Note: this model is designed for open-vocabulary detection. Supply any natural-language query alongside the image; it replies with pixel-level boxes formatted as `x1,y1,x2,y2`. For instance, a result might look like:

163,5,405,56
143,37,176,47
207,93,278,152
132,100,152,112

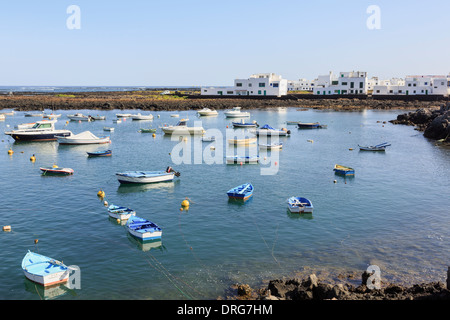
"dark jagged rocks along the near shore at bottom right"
229,267,450,300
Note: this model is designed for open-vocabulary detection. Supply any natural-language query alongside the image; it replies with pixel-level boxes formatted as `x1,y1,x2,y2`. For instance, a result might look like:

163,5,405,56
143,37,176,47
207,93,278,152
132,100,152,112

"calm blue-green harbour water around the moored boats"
0,108,450,300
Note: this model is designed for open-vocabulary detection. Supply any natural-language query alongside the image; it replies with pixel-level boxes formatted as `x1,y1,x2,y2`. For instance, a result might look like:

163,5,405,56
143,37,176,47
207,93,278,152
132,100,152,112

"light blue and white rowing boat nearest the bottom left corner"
22,250,69,287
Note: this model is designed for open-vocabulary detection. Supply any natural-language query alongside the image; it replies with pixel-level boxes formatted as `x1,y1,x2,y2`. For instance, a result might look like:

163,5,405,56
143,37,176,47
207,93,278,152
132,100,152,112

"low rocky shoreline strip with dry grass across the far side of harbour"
0,91,442,111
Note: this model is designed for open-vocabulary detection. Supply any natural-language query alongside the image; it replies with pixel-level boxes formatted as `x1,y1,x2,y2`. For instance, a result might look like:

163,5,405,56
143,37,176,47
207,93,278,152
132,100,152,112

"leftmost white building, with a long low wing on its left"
201,73,288,97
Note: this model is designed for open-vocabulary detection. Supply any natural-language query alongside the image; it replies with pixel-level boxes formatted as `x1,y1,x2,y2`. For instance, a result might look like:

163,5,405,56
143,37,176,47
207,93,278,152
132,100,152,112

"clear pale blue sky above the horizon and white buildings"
0,0,450,86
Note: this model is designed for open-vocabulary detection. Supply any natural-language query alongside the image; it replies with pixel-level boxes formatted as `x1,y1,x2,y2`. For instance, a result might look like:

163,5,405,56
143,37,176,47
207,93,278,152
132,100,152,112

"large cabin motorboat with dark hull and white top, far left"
5,120,72,141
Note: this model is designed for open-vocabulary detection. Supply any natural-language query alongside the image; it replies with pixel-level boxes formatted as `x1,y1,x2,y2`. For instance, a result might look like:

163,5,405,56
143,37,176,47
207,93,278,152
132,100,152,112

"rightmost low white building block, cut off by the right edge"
372,75,450,96
